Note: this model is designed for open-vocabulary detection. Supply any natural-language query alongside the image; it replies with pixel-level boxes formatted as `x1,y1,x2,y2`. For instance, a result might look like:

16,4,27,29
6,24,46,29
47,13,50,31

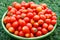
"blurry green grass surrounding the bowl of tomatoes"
0,0,60,40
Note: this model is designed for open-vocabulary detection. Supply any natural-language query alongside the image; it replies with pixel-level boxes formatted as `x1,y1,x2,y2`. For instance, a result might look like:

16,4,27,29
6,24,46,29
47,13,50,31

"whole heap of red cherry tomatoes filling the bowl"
4,1,57,38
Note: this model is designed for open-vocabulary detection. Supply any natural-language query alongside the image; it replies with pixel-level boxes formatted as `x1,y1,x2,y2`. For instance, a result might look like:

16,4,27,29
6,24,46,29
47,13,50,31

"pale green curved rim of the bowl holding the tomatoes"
2,11,57,40
